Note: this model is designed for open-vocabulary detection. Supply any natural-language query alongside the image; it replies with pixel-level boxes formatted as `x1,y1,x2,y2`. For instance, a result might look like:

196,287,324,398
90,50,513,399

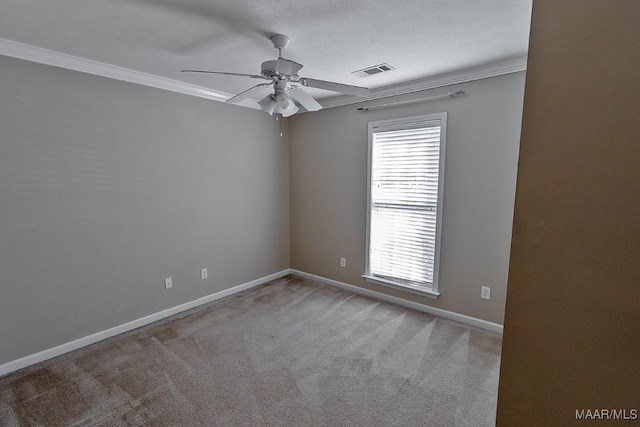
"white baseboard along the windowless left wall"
0,269,291,376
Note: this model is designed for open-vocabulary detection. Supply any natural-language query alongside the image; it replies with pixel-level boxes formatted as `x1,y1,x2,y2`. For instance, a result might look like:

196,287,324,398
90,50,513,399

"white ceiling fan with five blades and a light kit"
182,34,370,117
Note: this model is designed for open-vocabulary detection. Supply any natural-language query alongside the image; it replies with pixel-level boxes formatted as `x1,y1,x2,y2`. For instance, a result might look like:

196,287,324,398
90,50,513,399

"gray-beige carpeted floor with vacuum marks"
0,276,501,427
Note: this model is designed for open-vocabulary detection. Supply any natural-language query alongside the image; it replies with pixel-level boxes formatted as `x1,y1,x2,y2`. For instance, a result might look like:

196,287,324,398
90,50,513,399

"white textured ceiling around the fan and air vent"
0,0,532,103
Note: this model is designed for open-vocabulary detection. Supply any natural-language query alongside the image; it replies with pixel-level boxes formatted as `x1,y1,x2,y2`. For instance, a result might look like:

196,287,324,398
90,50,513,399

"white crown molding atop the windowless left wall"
0,38,260,110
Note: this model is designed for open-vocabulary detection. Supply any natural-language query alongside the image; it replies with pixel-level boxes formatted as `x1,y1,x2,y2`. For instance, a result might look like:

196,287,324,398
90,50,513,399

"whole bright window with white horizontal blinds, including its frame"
364,113,447,298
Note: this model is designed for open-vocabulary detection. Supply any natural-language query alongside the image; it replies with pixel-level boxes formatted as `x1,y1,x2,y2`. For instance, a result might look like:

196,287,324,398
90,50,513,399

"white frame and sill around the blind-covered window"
362,112,447,299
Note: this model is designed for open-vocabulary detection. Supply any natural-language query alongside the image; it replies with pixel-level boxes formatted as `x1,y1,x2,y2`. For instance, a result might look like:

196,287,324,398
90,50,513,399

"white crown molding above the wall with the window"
320,56,527,108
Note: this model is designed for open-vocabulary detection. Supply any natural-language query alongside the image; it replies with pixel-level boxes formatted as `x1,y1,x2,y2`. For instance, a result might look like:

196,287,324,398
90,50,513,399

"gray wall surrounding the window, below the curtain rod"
290,73,524,323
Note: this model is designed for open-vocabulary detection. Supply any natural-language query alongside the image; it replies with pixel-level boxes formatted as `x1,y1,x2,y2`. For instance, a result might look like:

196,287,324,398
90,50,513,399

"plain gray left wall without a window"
0,57,289,364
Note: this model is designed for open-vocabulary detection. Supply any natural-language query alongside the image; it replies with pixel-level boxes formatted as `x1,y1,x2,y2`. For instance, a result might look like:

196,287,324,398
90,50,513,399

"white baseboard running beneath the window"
291,269,503,334
